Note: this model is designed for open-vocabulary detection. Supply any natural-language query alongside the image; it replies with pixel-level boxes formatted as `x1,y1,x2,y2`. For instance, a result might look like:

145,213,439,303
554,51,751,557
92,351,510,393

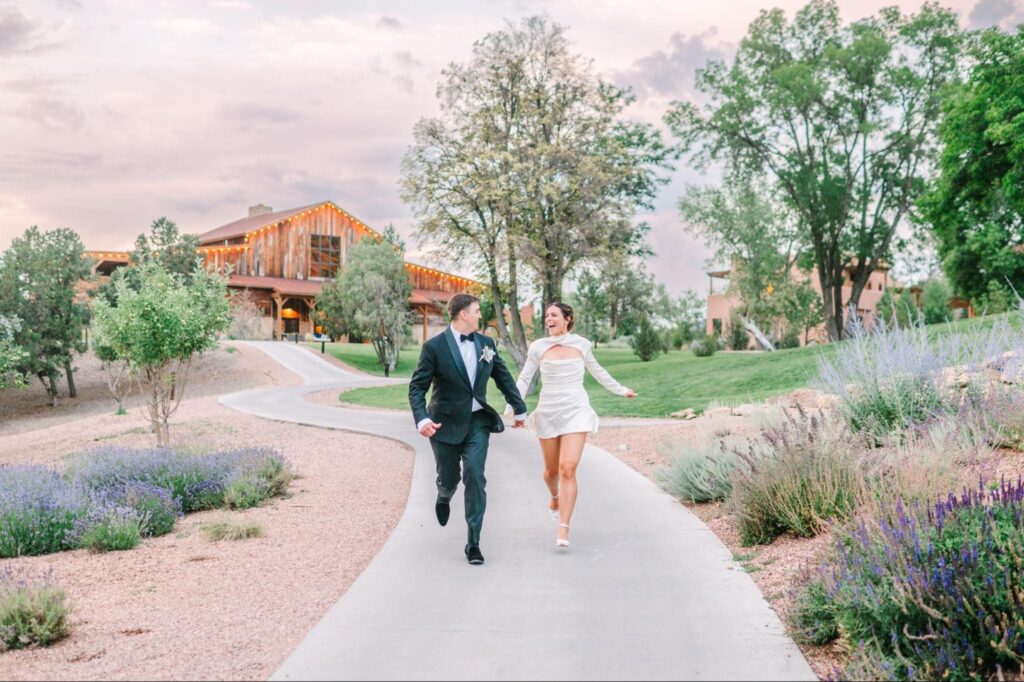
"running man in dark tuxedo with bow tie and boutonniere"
409,294,526,564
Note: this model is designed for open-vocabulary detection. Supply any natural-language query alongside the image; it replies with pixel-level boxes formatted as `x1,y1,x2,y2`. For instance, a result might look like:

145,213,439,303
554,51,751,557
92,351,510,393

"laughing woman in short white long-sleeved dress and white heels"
507,303,636,548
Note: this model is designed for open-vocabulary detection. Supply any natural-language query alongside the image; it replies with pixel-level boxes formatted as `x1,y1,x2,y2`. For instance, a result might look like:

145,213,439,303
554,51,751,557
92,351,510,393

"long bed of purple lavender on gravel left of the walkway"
0,447,294,557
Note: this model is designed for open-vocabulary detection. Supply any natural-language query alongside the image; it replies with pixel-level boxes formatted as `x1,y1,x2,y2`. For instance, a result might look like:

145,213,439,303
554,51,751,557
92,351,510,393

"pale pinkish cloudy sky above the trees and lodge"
0,0,1024,293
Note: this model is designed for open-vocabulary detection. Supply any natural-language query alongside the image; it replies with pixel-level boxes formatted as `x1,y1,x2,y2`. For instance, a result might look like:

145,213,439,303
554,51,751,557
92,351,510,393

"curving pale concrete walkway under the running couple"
220,342,816,680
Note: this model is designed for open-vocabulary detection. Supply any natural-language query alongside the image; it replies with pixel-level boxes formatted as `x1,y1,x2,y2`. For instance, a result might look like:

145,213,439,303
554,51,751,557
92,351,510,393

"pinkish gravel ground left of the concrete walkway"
0,343,413,679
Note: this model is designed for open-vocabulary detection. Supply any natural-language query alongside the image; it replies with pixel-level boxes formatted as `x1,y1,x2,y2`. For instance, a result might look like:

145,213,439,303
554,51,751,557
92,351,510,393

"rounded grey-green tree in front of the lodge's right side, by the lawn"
316,232,413,376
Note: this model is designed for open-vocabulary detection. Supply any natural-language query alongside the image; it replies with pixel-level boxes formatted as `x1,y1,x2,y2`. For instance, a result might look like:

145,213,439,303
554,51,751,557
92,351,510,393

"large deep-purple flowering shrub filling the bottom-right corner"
792,480,1024,679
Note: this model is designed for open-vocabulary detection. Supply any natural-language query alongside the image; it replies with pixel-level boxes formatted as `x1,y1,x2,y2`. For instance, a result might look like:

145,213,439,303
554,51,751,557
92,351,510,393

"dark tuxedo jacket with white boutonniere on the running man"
409,327,526,444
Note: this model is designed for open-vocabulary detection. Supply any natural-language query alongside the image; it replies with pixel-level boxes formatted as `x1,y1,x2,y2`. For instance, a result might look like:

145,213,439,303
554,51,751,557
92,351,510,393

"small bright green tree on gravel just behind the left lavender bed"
92,259,230,446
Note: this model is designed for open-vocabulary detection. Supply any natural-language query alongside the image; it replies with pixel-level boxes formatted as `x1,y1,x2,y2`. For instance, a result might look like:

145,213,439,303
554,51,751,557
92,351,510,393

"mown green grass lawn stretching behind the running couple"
315,313,1024,417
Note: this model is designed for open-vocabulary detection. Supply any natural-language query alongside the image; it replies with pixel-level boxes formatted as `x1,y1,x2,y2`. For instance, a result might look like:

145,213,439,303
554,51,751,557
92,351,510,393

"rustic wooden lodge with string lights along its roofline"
86,202,482,343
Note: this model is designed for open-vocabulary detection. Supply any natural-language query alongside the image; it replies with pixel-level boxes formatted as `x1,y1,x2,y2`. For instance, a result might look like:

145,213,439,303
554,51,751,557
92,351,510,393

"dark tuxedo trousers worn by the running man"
430,410,490,545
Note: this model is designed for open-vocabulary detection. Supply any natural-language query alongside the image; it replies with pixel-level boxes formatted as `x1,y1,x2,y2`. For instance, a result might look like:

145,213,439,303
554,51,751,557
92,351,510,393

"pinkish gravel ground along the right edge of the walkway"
589,415,842,679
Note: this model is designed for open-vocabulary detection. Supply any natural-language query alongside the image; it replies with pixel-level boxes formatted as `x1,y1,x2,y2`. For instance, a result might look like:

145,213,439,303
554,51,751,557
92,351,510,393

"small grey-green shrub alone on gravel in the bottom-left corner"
0,566,71,652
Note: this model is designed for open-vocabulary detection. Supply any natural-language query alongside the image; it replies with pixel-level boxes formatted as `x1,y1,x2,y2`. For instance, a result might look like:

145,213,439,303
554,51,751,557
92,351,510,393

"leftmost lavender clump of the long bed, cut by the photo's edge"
0,465,91,558
